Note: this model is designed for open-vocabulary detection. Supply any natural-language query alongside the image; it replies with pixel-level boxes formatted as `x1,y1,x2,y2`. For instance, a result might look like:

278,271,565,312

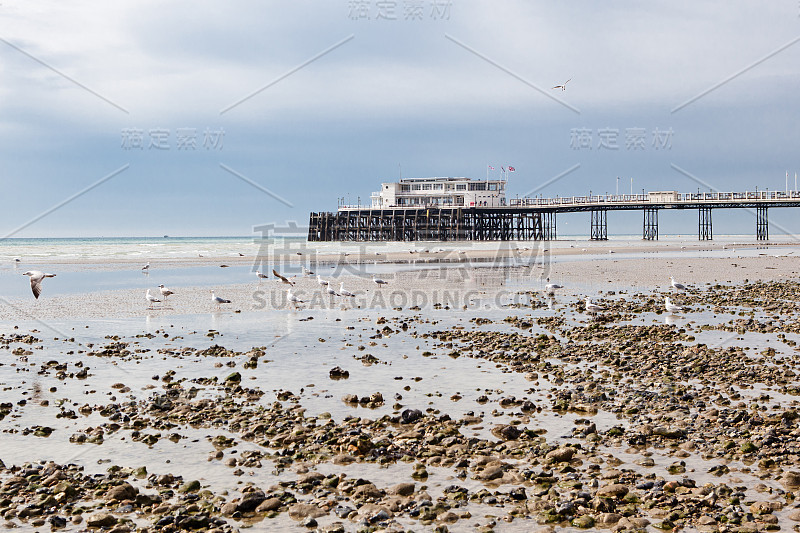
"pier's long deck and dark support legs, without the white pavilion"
308,191,800,242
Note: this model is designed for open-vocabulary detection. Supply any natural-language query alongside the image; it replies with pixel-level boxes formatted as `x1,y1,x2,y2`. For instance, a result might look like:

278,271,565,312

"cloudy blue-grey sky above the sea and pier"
0,0,800,237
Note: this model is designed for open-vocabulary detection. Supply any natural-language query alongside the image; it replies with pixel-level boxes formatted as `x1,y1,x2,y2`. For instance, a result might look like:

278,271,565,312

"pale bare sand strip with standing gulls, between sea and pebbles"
0,253,800,322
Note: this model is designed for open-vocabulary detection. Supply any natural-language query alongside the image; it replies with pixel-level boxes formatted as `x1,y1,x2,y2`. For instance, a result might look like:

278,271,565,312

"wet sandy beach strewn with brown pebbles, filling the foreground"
0,246,800,533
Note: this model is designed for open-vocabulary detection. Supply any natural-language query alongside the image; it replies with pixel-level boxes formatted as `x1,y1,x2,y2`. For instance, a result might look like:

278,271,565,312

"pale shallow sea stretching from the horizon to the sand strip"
0,233,793,298
